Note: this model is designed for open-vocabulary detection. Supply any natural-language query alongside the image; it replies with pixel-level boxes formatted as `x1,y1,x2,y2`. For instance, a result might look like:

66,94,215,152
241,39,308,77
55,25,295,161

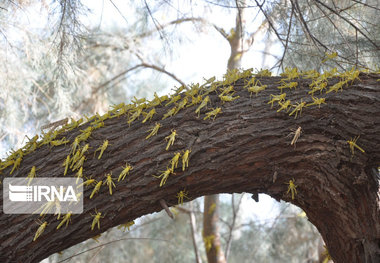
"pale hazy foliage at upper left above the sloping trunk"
0,0,168,156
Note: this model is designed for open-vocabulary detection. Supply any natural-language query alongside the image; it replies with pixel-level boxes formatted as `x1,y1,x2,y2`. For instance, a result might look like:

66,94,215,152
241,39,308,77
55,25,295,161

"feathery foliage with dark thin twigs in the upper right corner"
269,0,380,71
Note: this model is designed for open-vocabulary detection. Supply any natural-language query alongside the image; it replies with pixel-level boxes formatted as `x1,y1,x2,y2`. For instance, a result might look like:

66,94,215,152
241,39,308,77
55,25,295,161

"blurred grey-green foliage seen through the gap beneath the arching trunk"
50,194,319,263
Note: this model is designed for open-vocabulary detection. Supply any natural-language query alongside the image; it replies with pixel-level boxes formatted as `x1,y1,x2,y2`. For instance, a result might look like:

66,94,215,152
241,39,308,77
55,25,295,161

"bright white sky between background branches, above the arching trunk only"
83,0,282,94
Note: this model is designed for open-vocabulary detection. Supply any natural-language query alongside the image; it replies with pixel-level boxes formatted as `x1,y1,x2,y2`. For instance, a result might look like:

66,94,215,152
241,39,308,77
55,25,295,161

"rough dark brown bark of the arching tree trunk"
0,74,380,263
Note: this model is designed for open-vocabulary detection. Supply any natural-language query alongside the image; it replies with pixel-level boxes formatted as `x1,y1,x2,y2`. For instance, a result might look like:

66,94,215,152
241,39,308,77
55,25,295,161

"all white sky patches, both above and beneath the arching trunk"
0,0,288,225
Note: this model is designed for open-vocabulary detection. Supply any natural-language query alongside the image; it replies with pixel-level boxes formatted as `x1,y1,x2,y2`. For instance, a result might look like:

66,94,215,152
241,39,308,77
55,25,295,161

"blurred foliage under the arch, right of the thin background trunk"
220,198,319,263
